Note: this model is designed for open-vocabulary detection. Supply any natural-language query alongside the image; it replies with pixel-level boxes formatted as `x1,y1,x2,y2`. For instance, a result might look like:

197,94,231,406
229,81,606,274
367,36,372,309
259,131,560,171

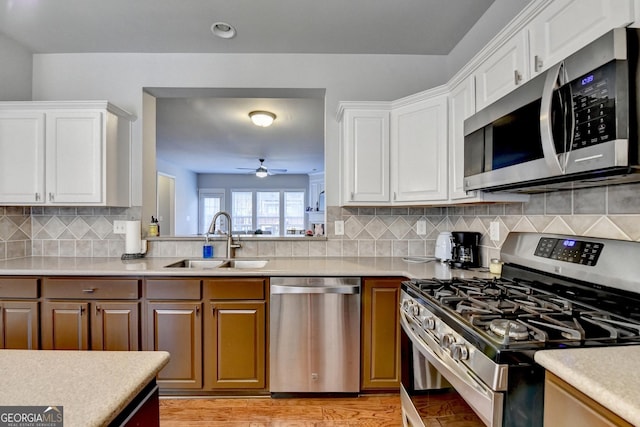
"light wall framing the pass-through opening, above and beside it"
33,53,446,205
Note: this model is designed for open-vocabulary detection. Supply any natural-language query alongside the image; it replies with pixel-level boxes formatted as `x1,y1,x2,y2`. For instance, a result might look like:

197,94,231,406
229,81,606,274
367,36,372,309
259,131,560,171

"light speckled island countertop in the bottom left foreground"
0,350,169,427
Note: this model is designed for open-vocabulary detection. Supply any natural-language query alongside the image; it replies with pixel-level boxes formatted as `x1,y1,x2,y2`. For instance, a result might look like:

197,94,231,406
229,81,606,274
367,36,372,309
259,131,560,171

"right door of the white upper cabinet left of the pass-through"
46,111,104,203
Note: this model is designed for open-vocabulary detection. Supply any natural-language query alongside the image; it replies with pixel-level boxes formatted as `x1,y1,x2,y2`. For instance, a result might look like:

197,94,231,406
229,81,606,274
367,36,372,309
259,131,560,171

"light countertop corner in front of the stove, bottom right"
534,345,640,425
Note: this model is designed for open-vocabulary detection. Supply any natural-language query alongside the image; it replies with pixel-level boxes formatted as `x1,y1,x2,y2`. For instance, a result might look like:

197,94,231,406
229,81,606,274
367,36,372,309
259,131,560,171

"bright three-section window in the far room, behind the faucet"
231,190,306,236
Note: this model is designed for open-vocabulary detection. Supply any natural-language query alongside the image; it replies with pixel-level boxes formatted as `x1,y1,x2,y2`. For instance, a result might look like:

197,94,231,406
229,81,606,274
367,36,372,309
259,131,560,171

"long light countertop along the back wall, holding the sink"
0,257,490,279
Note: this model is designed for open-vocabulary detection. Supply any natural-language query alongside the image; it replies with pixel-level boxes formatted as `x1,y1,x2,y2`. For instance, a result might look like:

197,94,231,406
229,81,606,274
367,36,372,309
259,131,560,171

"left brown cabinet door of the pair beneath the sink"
146,301,202,389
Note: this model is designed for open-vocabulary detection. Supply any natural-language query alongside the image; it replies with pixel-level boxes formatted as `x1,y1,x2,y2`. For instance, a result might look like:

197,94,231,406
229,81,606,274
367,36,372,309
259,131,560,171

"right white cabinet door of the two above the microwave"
529,0,634,75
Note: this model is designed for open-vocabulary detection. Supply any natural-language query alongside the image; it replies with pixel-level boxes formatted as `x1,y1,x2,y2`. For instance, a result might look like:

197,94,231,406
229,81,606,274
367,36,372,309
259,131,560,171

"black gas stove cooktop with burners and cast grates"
404,278,640,349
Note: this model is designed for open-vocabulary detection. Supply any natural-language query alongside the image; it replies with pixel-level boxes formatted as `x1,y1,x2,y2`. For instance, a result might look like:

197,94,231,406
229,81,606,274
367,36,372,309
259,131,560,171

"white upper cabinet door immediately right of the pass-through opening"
342,109,390,205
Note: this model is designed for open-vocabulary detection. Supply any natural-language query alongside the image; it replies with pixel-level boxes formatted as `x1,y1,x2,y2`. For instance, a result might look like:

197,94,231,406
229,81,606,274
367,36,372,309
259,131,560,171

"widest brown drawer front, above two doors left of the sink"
42,277,140,300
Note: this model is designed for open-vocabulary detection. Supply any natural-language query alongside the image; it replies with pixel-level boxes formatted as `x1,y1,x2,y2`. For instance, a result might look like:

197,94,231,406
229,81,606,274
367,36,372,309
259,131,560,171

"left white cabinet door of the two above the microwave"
474,31,529,111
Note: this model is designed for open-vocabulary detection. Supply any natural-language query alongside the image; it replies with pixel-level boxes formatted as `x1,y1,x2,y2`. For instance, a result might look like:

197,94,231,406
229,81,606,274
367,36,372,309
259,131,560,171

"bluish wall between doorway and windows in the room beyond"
156,159,198,236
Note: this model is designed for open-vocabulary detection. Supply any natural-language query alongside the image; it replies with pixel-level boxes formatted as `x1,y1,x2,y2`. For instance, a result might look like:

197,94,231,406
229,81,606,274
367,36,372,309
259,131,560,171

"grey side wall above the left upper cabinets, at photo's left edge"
0,34,32,101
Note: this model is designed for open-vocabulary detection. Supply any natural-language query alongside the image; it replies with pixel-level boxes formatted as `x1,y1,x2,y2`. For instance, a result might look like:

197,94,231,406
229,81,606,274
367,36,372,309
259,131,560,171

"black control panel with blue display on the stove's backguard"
534,237,604,266
